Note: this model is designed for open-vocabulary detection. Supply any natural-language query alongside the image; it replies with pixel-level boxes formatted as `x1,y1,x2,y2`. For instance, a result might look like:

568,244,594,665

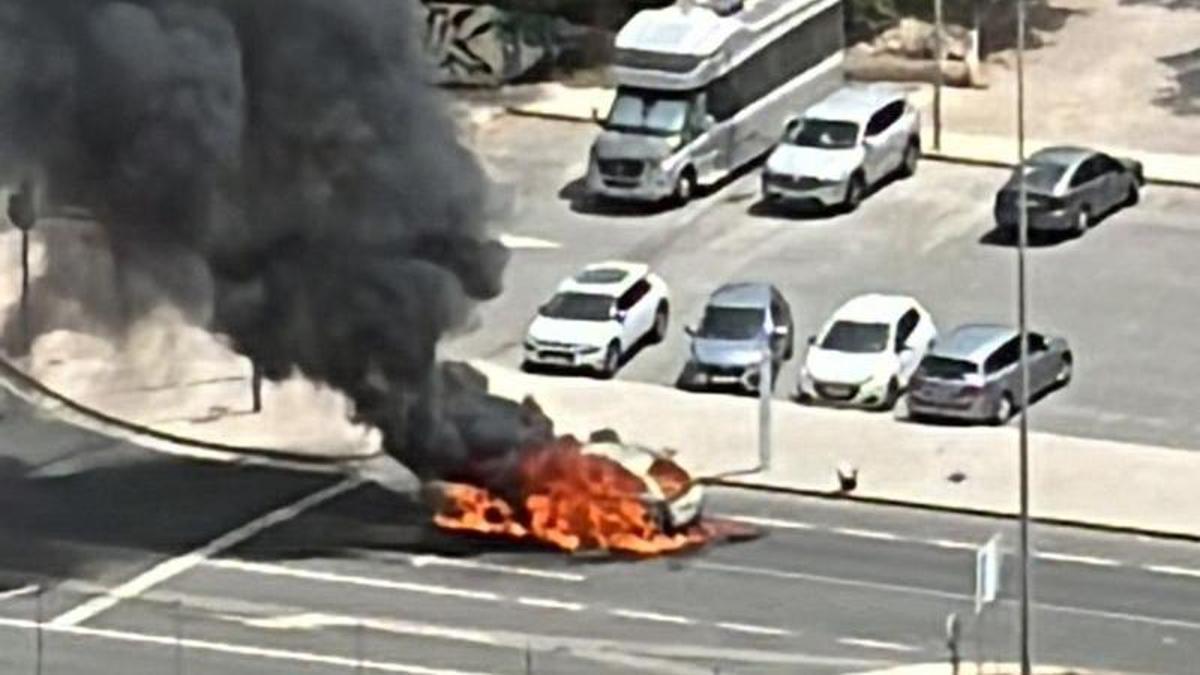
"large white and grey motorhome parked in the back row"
587,0,845,202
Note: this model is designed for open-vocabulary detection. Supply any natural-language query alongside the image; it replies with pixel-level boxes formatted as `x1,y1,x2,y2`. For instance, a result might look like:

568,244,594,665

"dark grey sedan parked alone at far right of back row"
995,145,1146,234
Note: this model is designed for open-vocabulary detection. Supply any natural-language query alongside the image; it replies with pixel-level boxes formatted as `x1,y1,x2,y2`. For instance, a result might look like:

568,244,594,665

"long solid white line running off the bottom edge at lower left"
0,619,488,675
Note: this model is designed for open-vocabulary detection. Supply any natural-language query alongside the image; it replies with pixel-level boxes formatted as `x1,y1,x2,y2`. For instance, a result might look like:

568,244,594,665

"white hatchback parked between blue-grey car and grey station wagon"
798,293,937,410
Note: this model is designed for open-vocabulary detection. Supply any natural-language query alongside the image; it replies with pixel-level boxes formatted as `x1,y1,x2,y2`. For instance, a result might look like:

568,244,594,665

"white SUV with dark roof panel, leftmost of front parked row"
524,262,671,377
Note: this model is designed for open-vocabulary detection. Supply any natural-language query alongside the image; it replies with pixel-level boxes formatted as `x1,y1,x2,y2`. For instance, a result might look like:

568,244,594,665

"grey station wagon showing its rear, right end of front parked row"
908,324,1074,424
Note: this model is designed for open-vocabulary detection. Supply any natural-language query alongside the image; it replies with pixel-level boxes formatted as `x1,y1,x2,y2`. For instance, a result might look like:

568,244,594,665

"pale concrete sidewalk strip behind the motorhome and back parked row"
504,83,1200,187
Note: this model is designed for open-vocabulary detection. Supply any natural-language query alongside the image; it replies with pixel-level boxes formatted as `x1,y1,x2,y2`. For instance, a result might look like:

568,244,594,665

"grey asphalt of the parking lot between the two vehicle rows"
444,117,1200,449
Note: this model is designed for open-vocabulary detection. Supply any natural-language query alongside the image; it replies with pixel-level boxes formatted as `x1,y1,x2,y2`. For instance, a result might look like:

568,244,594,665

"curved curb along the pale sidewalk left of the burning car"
0,357,383,468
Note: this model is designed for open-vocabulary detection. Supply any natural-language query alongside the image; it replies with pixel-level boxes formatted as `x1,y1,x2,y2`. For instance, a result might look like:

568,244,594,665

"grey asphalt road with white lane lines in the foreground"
0,393,1200,675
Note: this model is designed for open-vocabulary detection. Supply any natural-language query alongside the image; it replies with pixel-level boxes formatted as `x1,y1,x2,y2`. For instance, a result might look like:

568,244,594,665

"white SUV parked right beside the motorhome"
762,85,920,209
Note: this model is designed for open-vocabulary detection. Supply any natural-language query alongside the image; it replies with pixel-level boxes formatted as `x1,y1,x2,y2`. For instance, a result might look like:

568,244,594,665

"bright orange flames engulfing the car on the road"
434,440,707,555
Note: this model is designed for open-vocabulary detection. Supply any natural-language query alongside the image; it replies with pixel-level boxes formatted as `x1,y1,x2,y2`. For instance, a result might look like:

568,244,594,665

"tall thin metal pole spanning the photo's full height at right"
1016,0,1033,675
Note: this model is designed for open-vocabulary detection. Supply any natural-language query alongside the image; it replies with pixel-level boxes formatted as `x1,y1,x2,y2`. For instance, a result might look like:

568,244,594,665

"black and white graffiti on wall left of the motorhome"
425,2,553,85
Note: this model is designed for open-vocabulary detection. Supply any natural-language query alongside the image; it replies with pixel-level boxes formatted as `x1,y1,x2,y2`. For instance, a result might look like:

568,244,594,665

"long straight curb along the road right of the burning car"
707,479,1200,543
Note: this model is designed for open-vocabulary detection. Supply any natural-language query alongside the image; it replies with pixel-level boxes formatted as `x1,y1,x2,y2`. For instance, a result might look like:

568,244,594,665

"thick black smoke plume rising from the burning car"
0,0,550,478
